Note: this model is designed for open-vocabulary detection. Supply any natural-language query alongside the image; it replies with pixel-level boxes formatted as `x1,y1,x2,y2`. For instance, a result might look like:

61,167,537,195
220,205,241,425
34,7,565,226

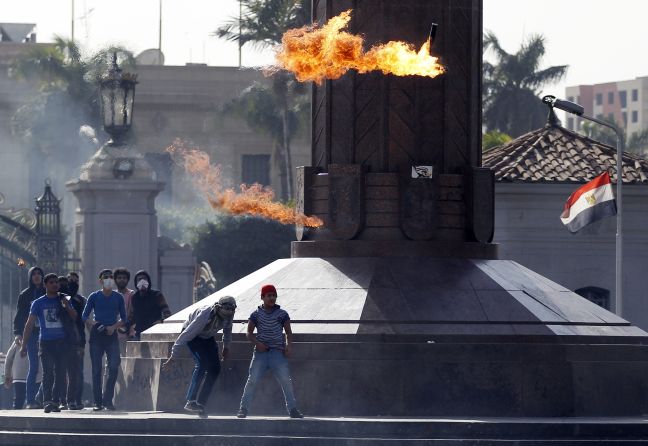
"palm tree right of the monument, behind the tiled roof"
483,32,567,137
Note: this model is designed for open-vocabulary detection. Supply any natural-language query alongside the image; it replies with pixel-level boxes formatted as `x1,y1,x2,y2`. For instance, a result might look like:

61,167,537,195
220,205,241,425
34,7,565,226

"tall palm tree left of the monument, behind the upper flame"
215,0,311,200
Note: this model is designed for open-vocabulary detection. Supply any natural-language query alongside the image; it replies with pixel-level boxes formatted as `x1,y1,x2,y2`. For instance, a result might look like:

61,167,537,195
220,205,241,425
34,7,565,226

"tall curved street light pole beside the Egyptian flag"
542,95,625,317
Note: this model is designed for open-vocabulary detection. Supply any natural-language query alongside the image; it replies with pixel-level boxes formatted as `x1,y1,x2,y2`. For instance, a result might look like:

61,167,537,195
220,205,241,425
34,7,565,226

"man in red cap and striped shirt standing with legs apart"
236,285,304,418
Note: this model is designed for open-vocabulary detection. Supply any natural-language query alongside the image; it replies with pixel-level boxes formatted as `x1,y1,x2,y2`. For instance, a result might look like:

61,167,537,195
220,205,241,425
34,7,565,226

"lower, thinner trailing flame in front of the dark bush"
166,140,324,228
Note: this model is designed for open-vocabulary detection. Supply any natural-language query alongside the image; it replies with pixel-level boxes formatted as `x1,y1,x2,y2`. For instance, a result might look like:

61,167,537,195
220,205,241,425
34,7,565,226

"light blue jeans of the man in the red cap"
241,349,297,411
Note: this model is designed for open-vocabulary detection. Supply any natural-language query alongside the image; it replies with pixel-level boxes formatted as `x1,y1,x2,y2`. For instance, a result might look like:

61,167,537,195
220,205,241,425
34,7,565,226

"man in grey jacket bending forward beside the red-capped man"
162,296,236,414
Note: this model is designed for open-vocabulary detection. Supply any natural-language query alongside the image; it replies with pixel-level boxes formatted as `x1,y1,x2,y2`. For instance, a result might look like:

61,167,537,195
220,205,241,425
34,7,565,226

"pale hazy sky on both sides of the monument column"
0,0,648,96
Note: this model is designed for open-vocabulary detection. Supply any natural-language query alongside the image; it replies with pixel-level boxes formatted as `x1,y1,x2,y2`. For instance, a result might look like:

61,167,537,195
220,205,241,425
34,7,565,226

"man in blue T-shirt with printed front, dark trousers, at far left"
20,274,77,413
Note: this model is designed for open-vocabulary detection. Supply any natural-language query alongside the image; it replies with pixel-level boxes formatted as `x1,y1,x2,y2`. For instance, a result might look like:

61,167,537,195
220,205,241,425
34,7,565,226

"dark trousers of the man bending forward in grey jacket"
187,337,220,405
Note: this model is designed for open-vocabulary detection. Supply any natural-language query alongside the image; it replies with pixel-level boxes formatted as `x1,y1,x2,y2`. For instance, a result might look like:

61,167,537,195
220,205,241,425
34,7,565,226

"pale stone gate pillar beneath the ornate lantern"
66,144,164,295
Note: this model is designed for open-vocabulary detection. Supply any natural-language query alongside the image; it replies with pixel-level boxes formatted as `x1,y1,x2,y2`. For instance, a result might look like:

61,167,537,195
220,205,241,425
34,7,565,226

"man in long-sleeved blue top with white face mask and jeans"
82,269,126,410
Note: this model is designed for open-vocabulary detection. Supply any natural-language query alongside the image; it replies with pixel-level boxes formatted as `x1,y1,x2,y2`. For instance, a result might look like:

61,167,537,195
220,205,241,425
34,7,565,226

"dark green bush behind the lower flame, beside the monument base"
191,216,295,288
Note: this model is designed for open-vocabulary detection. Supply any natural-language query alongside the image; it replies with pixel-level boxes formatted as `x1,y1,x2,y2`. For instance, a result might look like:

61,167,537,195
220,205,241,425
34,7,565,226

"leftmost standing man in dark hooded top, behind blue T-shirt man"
14,266,45,409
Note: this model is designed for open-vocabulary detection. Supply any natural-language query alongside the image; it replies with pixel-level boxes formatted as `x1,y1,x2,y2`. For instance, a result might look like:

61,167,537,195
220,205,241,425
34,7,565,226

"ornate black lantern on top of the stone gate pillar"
99,53,137,145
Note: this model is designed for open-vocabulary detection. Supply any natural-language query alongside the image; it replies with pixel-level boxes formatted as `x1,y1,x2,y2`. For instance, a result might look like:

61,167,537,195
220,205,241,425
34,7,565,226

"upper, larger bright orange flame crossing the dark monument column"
276,10,445,84
